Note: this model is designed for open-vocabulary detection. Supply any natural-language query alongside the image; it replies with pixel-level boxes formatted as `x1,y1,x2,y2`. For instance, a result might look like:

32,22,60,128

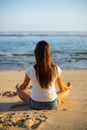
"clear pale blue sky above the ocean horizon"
0,0,87,31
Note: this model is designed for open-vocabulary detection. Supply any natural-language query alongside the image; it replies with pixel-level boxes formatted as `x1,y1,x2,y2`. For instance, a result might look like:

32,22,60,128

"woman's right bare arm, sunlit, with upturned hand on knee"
57,76,72,91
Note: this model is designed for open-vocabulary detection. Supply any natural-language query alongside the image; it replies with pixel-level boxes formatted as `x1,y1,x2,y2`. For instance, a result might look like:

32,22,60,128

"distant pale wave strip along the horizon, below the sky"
0,32,87,37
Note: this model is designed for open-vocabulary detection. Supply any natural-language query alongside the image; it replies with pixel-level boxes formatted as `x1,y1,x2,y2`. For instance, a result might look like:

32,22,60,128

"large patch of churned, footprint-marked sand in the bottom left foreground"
0,112,47,130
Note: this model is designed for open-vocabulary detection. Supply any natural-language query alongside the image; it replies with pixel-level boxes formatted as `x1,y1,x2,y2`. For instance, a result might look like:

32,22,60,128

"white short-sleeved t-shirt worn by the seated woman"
26,66,61,102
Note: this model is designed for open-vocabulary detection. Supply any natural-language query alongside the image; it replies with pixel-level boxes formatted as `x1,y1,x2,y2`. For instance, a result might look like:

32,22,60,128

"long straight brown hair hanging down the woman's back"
34,41,57,88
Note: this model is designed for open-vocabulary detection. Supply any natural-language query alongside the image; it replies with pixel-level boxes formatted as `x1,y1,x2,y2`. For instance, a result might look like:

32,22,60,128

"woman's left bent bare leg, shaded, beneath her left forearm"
16,90,30,104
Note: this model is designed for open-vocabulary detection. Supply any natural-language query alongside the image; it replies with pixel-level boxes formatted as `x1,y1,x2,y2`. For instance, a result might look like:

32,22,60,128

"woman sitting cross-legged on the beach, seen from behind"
16,41,71,110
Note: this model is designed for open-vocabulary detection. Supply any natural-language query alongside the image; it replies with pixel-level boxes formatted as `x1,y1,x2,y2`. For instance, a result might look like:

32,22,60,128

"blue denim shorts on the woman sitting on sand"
29,97,58,110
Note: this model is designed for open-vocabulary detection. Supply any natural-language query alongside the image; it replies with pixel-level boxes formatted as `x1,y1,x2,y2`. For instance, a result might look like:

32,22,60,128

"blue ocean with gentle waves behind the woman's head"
0,32,87,70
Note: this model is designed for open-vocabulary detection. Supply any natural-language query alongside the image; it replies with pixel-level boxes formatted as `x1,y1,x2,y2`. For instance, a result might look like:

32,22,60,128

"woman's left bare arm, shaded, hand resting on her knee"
16,74,30,90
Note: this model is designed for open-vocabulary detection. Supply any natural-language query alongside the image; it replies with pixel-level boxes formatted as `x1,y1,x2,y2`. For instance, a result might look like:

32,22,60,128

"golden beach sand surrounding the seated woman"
0,70,87,130
